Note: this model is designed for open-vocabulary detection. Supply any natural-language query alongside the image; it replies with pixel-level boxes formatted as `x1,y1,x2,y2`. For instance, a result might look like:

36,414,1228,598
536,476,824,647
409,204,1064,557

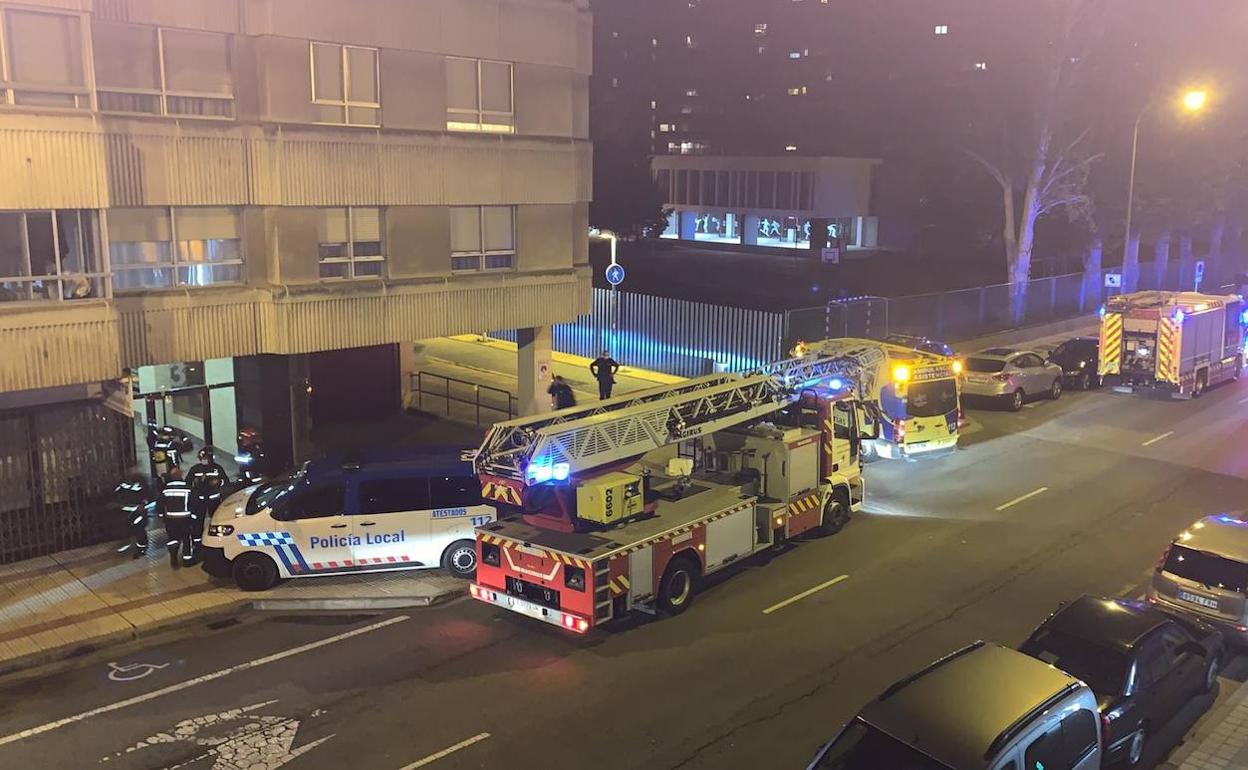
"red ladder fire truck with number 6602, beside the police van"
469,354,875,634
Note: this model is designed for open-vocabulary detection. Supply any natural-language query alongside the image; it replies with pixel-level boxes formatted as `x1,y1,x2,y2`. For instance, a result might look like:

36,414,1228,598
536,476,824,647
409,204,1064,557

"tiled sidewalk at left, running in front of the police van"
0,532,466,674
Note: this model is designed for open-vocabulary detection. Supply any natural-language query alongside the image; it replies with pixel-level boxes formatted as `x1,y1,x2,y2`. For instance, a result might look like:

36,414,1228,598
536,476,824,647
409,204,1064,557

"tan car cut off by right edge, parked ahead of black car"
1147,513,1248,646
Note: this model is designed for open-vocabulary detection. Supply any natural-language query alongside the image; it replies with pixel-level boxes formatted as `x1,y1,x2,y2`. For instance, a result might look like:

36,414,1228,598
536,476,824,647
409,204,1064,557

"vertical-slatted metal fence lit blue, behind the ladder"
490,288,785,377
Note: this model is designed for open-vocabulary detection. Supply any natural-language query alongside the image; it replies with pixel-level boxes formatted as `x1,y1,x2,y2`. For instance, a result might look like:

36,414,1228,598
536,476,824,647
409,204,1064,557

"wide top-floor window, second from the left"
92,24,235,119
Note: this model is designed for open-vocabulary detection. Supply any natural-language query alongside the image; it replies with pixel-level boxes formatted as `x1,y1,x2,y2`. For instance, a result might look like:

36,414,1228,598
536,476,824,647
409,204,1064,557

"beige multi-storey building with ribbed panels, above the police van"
0,0,592,560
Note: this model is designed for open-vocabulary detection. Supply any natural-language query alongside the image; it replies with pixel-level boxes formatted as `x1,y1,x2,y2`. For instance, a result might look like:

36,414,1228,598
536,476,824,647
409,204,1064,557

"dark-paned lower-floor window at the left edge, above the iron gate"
0,211,105,302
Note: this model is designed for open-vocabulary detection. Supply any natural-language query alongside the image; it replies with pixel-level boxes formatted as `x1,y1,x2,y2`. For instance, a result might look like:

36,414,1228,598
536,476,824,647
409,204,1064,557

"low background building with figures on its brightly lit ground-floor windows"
651,155,880,250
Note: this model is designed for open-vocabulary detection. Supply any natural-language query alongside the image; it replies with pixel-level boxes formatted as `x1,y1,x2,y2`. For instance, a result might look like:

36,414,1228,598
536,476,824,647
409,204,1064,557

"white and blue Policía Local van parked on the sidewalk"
203,449,497,590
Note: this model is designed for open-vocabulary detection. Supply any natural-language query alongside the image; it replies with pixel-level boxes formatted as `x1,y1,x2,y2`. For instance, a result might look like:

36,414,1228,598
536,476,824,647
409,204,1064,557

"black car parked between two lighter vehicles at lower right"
1020,597,1222,766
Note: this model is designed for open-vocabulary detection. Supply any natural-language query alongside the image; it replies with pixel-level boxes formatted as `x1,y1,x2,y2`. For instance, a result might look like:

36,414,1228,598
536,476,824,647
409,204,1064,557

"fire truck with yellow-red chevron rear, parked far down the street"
1099,291,1248,397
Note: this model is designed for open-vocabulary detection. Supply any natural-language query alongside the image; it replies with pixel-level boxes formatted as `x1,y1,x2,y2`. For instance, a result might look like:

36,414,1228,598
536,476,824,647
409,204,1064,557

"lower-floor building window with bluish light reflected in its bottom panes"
109,206,242,291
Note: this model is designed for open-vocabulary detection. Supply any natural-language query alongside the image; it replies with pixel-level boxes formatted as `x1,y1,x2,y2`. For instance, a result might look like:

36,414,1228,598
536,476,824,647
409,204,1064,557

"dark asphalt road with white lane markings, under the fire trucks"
0,381,1248,770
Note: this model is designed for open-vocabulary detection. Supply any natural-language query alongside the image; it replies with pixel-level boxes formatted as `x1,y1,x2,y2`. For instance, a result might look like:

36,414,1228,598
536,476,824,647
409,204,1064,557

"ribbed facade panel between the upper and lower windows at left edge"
0,125,106,210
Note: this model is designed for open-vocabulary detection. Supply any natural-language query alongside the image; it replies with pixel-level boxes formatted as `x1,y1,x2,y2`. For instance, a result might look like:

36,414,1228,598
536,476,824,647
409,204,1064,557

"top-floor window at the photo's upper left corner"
0,9,91,110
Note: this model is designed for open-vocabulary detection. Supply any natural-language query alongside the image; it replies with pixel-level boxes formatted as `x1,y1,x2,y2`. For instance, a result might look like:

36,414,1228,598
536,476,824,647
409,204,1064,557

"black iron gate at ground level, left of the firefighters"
0,402,135,564
